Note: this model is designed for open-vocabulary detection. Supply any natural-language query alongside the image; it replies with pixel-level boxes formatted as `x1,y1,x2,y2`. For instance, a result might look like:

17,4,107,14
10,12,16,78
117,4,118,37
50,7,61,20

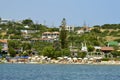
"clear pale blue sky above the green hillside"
0,0,120,27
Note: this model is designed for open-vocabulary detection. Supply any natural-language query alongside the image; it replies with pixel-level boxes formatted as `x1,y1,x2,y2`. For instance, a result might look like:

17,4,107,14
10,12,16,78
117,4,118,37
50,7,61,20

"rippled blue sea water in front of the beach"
0,64,120,80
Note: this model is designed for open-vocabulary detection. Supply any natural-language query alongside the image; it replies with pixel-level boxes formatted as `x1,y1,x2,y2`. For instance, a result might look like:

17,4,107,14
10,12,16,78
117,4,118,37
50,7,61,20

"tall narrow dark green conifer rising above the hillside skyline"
60,18,68,49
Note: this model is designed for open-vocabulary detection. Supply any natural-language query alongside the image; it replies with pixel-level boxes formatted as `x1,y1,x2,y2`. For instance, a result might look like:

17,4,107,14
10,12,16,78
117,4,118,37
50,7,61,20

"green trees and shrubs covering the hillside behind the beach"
0,18,120,58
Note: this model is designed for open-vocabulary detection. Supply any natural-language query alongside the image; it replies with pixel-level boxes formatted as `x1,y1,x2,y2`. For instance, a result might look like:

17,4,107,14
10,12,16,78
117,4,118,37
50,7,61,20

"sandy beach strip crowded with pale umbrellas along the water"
0,56,120,65
